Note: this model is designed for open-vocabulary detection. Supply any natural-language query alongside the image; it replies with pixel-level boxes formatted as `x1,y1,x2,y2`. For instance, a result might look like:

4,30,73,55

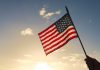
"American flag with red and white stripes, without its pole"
38,13,77,55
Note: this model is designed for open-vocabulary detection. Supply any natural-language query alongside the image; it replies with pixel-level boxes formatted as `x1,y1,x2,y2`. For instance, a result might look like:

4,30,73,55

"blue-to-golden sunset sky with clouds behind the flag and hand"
0,0,100,70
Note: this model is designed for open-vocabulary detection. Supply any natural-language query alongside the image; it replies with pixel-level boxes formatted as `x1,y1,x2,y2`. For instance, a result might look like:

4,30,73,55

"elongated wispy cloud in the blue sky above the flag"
39,8,61,19
